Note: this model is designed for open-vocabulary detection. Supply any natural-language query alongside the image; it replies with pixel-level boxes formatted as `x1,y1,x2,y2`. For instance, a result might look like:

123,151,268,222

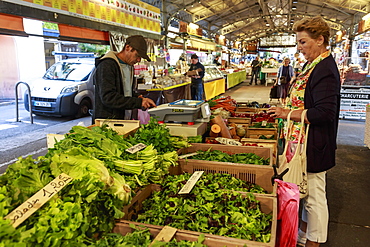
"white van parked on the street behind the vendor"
24,57,95,117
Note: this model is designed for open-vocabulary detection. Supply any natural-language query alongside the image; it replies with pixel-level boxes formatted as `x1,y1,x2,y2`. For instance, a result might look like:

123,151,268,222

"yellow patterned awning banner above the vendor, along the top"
4,0,161,33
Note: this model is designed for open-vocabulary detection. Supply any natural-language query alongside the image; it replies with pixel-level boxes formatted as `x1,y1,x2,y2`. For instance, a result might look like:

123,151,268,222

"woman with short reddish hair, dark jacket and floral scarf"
268,16,341,247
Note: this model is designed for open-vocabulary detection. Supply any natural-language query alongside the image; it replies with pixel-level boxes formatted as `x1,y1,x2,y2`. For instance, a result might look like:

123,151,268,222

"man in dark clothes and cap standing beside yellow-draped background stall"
188,54,205,100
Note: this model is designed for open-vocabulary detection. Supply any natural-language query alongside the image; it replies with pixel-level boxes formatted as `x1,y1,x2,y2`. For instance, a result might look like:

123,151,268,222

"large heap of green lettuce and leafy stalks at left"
0,123,181,247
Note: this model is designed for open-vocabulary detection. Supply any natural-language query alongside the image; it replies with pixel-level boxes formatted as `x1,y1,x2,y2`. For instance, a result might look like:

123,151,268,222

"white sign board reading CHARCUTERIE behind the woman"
339,92,370,119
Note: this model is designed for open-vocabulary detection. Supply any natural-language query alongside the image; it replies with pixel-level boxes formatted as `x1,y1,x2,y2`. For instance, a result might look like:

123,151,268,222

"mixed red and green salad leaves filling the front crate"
136,174,272,243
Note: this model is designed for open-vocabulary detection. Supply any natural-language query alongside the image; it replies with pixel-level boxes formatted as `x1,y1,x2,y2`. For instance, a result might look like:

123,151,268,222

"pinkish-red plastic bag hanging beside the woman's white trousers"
275,179,299,247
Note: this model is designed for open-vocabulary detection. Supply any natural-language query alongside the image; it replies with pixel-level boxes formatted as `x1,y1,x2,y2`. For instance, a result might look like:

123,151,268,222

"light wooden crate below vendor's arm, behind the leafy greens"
95,119,140,137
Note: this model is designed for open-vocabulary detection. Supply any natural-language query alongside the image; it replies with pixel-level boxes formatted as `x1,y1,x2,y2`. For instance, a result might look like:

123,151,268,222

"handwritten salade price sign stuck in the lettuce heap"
5,173,73,228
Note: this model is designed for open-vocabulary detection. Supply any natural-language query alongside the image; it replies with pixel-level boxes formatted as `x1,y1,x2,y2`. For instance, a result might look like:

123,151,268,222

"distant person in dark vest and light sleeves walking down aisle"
275,57,295,106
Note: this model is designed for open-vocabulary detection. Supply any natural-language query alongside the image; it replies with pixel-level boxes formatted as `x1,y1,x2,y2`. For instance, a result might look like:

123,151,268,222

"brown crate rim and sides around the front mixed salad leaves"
117,184,277,247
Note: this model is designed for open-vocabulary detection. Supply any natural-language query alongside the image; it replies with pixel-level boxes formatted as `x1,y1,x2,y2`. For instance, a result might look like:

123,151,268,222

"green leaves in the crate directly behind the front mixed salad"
188,149,270,165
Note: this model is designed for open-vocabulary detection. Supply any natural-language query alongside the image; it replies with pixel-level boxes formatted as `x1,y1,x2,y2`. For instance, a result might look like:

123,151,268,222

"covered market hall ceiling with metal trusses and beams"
143,0,370,41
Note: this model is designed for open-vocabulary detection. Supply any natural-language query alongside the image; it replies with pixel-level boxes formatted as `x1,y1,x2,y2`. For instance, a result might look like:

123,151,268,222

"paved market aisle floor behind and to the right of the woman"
224,80,370,247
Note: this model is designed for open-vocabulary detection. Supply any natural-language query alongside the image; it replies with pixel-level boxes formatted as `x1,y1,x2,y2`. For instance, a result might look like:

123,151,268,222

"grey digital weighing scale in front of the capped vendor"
148,99,211,125
